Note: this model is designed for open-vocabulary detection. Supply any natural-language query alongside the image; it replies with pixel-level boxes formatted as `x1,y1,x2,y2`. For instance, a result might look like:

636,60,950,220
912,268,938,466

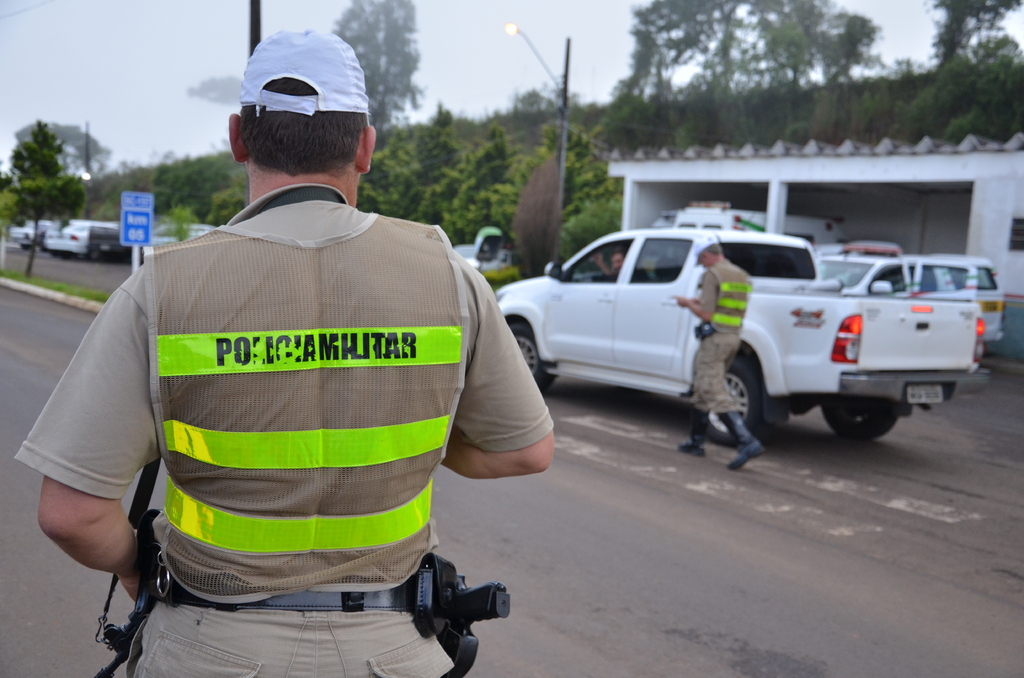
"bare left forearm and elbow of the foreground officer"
39,477,138,598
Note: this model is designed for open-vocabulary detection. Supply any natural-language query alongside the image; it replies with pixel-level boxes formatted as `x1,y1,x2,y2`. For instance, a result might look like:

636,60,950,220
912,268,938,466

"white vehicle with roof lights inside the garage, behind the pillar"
651,201,844,245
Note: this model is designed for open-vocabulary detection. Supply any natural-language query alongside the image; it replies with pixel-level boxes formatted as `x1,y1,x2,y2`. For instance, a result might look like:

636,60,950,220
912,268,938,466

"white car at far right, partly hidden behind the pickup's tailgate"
904,254,1006,348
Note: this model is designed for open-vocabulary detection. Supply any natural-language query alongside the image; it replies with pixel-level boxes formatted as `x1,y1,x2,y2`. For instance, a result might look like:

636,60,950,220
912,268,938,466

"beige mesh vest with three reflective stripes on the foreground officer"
146,208,466,601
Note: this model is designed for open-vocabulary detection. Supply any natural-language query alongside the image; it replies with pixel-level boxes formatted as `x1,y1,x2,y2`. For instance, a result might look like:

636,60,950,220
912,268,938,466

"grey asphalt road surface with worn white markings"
0,289,1024,678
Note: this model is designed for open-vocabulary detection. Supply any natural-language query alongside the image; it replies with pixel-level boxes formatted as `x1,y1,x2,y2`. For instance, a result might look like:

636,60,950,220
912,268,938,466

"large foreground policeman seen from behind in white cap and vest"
17,32,553,678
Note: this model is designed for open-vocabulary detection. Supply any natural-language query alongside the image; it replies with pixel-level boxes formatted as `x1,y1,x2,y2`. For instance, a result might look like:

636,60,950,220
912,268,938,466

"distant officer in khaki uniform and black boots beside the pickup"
676,243,764,470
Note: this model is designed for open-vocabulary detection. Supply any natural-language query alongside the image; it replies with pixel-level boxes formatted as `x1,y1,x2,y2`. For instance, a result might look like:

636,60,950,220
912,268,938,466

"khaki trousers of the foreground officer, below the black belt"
126,603,452,678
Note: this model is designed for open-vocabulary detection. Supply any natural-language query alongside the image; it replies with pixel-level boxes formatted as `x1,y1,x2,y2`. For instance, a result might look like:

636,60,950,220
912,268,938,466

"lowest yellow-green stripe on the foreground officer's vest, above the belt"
164,478,433,553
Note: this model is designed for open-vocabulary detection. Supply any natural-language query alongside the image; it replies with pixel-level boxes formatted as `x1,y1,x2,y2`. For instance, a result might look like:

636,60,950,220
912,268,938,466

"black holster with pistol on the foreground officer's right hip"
411,553,511,678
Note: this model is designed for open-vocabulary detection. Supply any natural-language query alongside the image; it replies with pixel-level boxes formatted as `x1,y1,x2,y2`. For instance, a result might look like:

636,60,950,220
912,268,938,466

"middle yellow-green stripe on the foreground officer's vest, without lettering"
164,416,449,468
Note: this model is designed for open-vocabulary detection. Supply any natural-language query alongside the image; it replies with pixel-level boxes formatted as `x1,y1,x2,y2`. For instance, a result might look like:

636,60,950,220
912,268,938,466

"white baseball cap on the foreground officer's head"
239,31,370,116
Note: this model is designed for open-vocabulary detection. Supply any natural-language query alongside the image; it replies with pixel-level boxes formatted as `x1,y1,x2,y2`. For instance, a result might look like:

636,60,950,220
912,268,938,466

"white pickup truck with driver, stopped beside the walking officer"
497,228,988,442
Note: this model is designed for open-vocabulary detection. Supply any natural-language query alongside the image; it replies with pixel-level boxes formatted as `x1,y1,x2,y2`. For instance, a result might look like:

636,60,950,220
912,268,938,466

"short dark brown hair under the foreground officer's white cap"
241,78,368,176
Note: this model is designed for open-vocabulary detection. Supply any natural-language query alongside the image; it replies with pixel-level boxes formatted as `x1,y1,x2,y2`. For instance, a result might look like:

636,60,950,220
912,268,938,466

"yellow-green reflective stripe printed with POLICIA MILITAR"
157,326,462,377
